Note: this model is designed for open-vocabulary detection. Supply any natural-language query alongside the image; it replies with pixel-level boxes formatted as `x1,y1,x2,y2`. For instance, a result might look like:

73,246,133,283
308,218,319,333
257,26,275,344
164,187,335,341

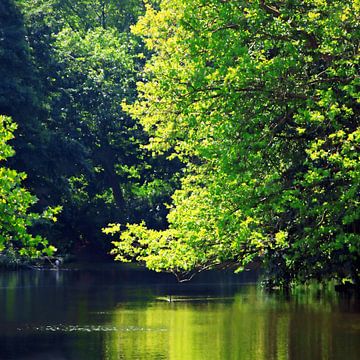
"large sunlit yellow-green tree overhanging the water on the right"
105,0,360,286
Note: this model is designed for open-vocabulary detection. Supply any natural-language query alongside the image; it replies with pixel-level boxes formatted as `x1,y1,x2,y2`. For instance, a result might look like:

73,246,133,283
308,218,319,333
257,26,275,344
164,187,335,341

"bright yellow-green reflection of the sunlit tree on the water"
103,287,359,360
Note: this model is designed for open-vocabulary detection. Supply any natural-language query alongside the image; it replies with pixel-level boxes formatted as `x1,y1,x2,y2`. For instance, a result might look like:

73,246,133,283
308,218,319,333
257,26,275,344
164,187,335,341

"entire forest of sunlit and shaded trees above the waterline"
0,0,360,287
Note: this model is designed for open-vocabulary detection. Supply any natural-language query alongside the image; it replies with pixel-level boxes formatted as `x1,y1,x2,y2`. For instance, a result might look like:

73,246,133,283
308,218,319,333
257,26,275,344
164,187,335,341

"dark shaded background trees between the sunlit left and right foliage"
0,0,179,251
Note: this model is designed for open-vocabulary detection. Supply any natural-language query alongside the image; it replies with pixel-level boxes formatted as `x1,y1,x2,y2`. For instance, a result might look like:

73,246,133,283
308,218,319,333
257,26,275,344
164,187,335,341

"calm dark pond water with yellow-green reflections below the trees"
0,264,360,360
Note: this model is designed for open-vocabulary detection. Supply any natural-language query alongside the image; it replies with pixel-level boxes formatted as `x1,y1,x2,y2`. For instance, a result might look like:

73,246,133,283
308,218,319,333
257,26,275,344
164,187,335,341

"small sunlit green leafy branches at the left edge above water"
0,116,60,257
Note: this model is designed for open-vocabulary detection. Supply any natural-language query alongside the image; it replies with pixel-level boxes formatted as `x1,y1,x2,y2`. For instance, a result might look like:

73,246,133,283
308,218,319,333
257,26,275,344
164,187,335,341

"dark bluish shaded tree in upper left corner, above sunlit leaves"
0,0,49,183
